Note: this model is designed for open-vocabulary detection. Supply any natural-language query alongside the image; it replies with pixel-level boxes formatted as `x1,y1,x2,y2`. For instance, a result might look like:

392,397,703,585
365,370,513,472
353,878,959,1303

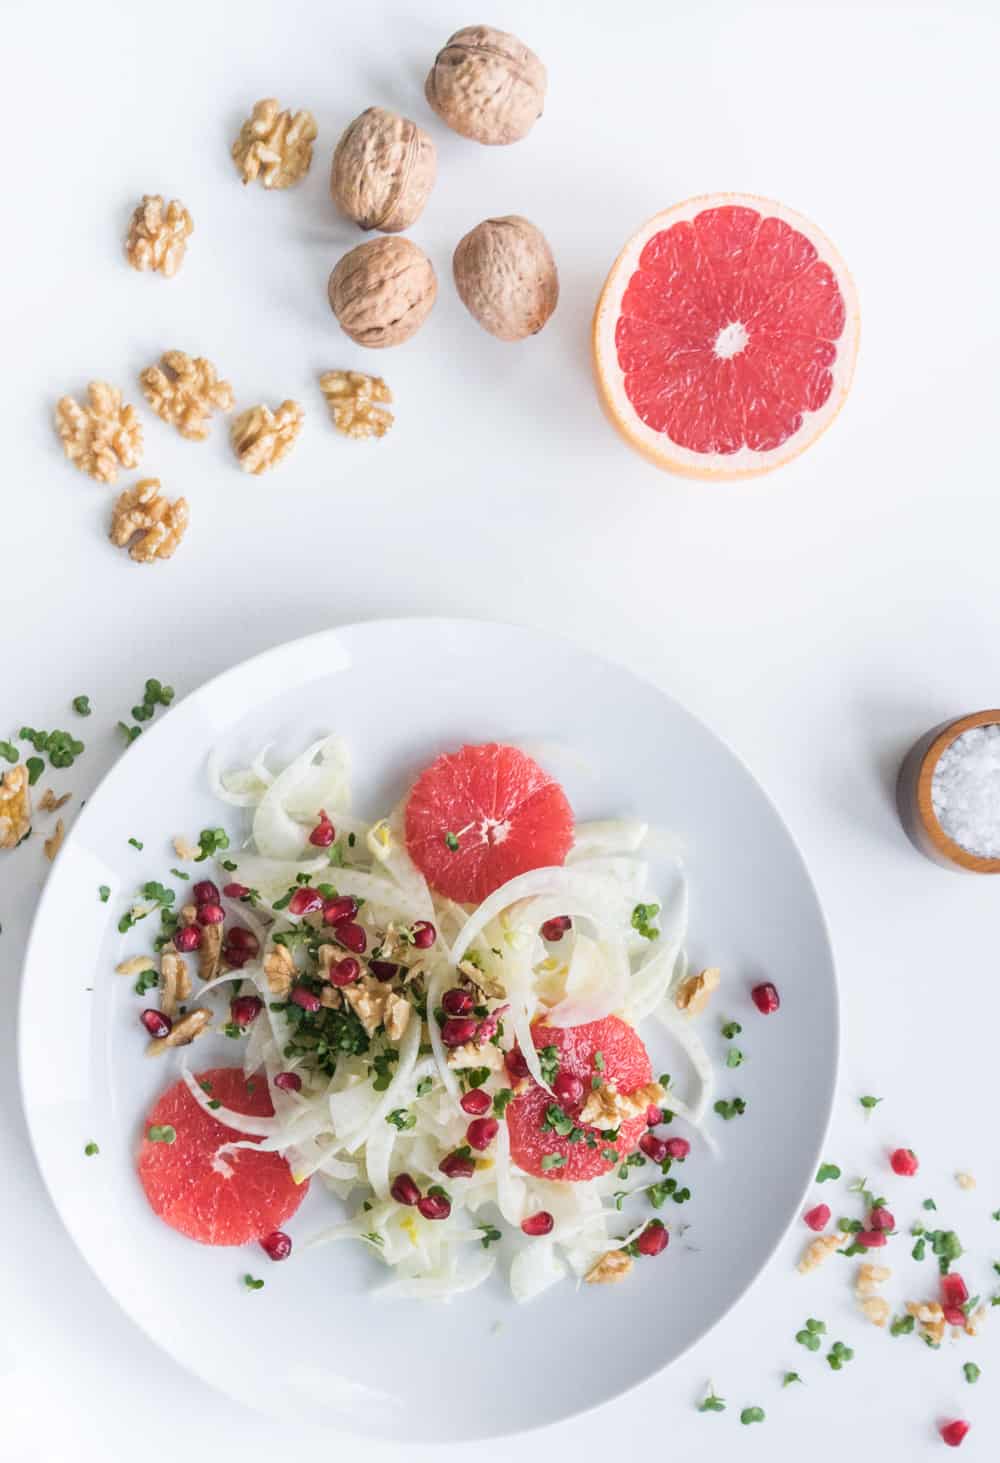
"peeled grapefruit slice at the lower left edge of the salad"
139,1067,308,1245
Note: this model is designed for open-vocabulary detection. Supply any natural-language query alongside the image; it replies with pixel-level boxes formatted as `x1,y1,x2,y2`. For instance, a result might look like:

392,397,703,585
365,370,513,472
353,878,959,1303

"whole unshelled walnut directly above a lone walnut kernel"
329,236,437,350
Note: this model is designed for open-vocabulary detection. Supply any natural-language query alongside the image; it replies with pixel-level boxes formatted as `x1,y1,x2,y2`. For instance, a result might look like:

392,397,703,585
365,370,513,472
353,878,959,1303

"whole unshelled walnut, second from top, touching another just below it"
330,107,437,234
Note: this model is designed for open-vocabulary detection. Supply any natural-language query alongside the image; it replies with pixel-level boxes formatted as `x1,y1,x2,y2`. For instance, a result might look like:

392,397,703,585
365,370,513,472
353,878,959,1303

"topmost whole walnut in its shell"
424,25,547,145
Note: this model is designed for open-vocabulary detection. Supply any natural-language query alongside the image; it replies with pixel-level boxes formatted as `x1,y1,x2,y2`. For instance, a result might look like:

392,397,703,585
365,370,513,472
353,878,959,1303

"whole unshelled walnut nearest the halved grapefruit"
452,214,558,341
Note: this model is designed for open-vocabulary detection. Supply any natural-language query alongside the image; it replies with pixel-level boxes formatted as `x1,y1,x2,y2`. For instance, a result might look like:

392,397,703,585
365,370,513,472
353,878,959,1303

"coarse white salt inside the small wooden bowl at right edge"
931,723,1000,859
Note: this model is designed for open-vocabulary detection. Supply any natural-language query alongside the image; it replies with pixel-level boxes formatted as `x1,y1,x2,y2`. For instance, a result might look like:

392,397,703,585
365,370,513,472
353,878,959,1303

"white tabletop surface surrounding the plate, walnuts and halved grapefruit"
0,0,1000,1463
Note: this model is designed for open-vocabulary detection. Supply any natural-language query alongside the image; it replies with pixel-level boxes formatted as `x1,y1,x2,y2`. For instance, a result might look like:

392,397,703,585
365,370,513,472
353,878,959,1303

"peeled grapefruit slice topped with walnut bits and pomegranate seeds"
506,1015,652,1182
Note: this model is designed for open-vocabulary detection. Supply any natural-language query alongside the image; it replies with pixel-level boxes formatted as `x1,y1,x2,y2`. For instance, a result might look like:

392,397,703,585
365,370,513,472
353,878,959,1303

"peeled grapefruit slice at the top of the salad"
406,742,573,904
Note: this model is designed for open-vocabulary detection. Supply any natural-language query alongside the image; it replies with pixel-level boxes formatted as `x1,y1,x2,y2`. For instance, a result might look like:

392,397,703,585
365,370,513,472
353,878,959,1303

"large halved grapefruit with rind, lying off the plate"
592,193,858,480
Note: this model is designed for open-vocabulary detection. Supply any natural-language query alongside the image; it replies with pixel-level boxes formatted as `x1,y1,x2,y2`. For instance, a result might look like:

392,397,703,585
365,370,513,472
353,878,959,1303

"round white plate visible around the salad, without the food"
20,620,838,1443
